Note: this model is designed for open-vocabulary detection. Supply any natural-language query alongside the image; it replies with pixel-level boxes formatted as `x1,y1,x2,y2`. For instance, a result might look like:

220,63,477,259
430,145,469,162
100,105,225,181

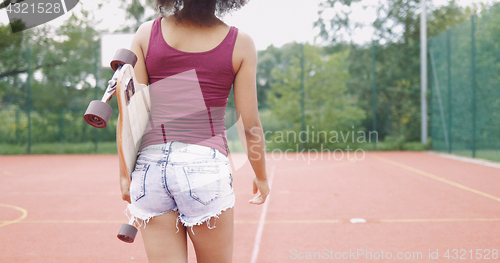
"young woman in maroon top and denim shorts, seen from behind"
121,0,269,263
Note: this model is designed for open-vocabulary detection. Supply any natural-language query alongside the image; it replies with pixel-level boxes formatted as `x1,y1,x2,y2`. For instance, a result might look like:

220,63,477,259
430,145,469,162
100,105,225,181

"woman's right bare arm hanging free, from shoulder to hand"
233,30,269,204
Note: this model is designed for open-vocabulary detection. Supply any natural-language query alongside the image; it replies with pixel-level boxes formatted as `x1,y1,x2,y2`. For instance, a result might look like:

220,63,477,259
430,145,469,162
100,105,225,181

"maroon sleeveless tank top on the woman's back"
140,17,238,155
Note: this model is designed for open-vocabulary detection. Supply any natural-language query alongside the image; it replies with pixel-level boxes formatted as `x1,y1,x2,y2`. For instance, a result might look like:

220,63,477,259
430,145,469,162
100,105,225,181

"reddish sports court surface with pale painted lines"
0,152,500,263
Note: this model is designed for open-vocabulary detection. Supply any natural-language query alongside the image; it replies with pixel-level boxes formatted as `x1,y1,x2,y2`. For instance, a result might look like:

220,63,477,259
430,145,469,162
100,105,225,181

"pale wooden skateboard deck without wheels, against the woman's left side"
116,64,151,183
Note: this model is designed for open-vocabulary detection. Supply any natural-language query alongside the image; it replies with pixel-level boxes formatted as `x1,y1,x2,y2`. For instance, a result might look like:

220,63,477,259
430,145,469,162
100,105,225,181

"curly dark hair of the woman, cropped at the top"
156,0,249,26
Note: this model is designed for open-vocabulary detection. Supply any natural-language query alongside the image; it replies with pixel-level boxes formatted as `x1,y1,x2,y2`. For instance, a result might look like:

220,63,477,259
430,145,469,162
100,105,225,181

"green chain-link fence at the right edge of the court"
429,5,500,161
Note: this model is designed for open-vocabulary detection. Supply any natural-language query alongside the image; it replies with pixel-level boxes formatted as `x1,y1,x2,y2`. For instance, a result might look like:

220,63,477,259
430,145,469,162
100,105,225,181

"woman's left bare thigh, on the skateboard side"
141,211,187,263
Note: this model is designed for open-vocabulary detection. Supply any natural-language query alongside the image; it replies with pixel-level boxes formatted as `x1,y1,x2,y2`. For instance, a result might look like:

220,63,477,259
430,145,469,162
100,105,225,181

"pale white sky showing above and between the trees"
0,0,494,50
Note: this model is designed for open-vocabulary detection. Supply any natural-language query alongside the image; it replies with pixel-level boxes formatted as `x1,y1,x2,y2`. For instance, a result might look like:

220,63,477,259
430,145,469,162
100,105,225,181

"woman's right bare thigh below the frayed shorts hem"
187,208,234,263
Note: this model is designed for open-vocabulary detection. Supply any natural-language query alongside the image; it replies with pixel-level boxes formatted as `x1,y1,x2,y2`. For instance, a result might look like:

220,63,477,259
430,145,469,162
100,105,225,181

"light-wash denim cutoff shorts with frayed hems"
127,141,235,228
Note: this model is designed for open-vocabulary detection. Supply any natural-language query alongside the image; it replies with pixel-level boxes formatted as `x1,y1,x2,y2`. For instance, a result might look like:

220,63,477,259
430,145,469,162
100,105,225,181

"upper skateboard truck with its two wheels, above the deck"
83,48,137,129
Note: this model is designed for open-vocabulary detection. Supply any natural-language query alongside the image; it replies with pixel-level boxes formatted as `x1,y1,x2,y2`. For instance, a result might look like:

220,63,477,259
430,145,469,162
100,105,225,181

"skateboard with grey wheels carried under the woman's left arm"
84,49,151,243
